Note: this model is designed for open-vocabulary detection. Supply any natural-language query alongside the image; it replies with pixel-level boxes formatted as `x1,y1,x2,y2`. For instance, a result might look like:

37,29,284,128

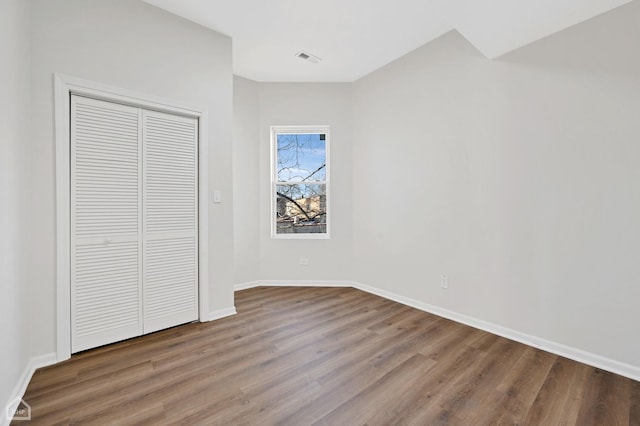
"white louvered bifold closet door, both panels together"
71,95,198,352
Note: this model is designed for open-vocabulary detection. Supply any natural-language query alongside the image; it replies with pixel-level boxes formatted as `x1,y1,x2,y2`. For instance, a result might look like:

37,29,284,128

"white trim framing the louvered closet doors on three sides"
54,74,209,362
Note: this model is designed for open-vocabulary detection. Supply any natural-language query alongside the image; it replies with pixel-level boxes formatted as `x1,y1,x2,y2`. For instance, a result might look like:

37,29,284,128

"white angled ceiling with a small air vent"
144,0,630,82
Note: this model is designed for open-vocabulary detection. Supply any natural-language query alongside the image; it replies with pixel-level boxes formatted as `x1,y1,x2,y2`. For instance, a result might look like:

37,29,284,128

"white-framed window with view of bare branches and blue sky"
271,126,329,238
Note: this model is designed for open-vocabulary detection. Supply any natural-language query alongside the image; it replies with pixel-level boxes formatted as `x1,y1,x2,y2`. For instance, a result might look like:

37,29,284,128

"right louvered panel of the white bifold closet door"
143,111,198,333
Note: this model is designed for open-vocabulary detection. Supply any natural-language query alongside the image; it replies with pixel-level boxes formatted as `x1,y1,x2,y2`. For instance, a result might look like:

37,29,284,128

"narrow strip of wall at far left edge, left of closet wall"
0,0,30,412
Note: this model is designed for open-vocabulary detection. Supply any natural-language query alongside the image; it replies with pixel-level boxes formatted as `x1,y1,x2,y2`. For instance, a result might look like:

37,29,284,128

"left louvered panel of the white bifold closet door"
71,96,142,352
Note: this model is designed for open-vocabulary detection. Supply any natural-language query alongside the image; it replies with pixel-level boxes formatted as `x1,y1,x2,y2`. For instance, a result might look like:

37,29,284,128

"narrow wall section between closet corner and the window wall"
233,76,260,283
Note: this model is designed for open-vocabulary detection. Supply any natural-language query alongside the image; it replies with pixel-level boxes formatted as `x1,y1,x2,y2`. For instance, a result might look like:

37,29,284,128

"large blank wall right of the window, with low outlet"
353,2,640,368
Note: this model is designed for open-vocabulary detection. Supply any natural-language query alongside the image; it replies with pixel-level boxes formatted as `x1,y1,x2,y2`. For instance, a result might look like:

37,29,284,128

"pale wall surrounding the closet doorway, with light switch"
27,0,233,360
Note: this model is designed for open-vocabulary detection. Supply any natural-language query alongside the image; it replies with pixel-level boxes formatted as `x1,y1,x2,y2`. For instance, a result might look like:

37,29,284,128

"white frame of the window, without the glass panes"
270,125,331,240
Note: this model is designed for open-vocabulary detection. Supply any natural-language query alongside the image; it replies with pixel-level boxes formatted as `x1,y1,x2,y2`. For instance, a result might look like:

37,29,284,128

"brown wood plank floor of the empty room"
14,287,640,426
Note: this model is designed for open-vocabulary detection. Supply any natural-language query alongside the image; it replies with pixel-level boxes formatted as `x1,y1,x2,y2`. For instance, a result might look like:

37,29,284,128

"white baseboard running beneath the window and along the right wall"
234,280,640,381
